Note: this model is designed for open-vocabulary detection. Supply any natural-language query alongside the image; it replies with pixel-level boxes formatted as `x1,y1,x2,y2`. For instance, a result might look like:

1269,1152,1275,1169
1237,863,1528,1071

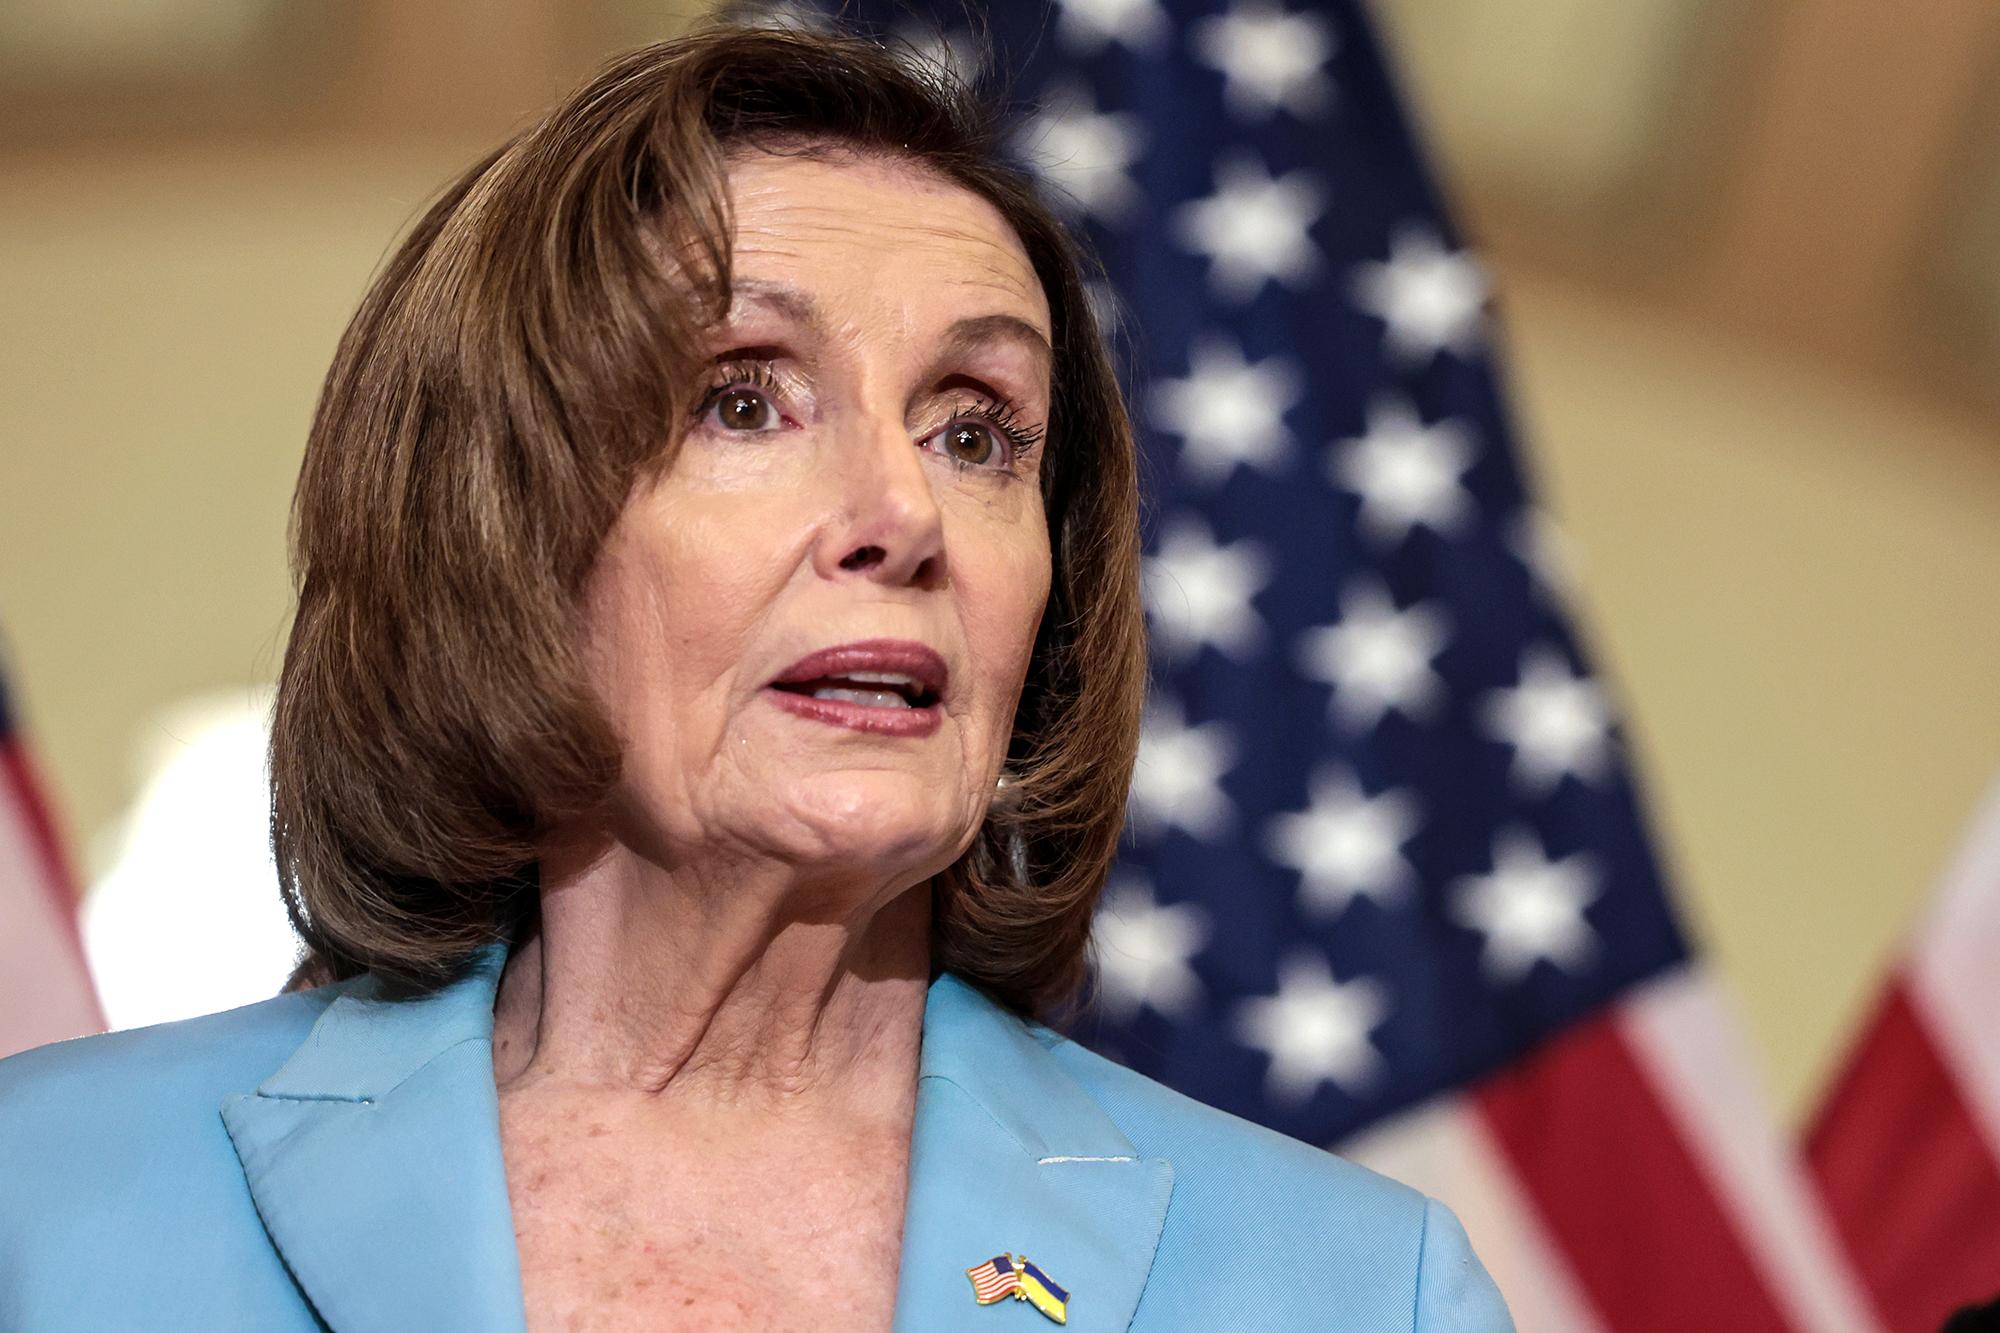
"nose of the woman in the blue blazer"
814,402,948,588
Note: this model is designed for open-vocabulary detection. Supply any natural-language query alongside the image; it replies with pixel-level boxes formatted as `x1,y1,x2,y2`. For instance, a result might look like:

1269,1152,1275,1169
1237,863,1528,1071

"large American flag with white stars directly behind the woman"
790,0,1876,1333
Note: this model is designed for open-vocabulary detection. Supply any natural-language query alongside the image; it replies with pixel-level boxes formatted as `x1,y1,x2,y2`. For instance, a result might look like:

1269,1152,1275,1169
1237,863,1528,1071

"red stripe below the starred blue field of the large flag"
1474,1011,1790,1333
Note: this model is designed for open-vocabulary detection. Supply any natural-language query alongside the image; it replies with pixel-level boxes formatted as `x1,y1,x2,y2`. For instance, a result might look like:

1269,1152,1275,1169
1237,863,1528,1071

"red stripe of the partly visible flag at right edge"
1806,983,2000,1333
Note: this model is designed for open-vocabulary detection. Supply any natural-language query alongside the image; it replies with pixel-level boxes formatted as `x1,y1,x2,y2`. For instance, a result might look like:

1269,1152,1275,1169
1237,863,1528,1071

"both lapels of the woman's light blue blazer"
222,947,1174,1333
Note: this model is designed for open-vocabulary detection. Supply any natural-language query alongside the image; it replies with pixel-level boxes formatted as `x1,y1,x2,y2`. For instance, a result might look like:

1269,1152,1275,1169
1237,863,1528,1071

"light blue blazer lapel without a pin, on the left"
222,949,524,1333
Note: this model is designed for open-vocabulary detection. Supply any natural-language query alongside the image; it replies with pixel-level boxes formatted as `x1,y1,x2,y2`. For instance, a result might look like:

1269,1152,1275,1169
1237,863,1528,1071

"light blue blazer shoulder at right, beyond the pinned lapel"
1038,1031,1512,1333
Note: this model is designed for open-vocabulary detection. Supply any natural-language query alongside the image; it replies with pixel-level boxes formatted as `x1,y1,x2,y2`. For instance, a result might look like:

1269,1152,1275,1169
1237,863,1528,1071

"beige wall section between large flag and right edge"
1508,284,2000,1117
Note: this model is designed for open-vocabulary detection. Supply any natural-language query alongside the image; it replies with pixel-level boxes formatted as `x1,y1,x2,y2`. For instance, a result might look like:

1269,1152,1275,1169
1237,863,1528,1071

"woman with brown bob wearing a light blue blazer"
0,23,1508,1333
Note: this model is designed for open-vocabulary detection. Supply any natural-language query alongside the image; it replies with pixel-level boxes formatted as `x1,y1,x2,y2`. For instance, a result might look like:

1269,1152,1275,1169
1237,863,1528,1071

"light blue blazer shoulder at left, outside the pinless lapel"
0,991,334,1333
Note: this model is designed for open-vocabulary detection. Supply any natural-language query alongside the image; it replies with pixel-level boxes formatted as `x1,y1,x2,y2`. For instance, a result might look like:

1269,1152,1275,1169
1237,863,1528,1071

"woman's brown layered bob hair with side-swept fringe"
272,28,1144,1013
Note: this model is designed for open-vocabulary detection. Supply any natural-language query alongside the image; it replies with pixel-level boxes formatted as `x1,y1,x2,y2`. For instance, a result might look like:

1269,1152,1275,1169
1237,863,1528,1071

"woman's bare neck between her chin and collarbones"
494,845,930,1111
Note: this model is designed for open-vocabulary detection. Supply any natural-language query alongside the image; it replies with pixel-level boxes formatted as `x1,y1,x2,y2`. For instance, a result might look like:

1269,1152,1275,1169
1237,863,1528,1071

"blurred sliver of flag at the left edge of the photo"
0,648,104,1057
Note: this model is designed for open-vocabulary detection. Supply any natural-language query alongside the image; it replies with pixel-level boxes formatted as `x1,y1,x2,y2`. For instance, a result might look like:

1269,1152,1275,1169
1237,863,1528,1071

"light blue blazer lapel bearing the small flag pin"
896,975,1174,1333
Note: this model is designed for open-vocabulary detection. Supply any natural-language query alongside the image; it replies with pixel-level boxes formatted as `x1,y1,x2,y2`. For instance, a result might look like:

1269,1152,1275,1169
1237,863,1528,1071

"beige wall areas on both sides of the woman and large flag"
0,83,2000,1115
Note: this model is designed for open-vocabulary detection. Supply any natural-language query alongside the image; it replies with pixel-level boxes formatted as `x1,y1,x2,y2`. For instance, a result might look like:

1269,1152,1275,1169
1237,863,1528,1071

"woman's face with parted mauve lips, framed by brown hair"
590,154,1050,895
